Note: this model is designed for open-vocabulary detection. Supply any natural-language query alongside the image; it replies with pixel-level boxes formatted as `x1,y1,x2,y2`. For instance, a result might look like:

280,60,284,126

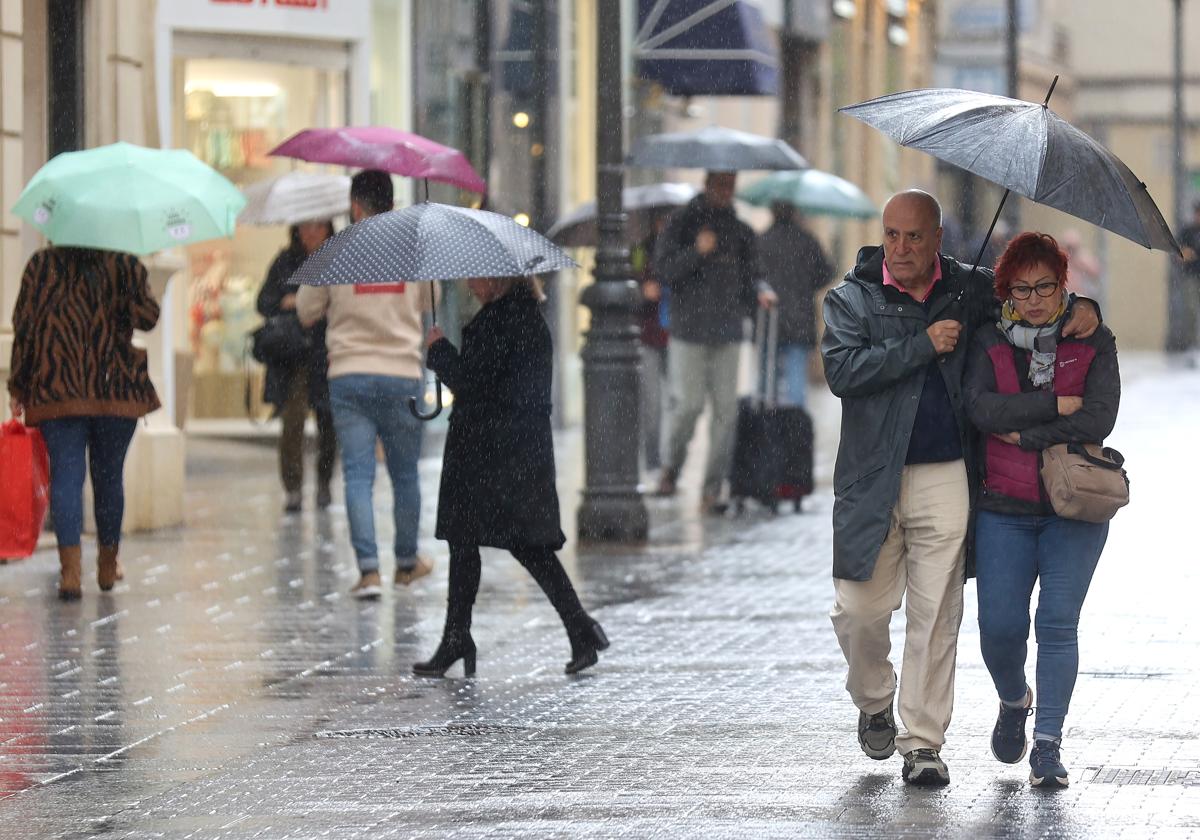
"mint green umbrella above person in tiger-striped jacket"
12,143,246,254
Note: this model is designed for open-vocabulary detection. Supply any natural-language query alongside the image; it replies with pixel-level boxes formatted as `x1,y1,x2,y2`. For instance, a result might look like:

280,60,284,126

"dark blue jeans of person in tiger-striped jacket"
37,416,137,547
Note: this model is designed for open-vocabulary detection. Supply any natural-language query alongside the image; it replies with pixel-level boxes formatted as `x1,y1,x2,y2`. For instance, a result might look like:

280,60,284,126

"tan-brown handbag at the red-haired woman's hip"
1042,443,1129,522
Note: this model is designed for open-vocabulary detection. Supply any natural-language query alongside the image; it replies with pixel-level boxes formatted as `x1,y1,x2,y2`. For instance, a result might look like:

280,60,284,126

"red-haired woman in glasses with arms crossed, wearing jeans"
965,233,1121,787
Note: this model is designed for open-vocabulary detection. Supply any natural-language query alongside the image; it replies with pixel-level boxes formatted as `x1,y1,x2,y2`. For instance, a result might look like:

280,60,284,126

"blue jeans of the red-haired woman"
976,510,1109,739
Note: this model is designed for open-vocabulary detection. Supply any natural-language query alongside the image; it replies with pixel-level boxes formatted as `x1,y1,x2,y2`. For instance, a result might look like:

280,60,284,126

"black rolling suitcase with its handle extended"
730,310,812,512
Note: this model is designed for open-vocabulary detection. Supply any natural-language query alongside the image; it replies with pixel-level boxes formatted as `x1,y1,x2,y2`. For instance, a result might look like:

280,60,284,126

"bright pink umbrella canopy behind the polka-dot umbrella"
270,126,487,193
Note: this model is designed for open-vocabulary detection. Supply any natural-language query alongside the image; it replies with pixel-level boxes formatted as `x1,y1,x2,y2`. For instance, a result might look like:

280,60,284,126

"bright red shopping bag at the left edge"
0,420,50,558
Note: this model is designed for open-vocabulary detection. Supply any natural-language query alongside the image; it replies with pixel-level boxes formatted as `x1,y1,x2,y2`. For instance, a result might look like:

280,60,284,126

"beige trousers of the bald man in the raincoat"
830,461,970,752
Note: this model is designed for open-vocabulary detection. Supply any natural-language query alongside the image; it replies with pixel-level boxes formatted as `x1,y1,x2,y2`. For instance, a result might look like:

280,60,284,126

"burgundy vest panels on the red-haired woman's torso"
984,341,1096,503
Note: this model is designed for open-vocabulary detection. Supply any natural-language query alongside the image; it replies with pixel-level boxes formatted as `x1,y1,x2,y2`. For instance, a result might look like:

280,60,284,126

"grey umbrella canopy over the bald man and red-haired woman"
840,88,1178,253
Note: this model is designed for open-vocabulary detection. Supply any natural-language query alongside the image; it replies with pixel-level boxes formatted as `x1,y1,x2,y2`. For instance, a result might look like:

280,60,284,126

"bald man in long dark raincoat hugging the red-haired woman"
821,190,1099,784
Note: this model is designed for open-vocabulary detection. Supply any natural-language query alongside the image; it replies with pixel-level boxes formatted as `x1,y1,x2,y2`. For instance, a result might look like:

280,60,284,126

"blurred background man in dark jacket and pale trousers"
654,172,776,512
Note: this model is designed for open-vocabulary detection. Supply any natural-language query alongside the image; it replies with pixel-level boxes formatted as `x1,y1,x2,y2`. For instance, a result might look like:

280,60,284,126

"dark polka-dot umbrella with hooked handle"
290,203,577,420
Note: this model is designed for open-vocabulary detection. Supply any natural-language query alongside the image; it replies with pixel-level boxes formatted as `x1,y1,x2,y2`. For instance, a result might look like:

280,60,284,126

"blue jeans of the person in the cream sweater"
329,373,425,574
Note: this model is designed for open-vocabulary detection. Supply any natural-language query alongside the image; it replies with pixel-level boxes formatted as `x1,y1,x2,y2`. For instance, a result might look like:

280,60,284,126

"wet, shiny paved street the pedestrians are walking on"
0,358,1200,838
